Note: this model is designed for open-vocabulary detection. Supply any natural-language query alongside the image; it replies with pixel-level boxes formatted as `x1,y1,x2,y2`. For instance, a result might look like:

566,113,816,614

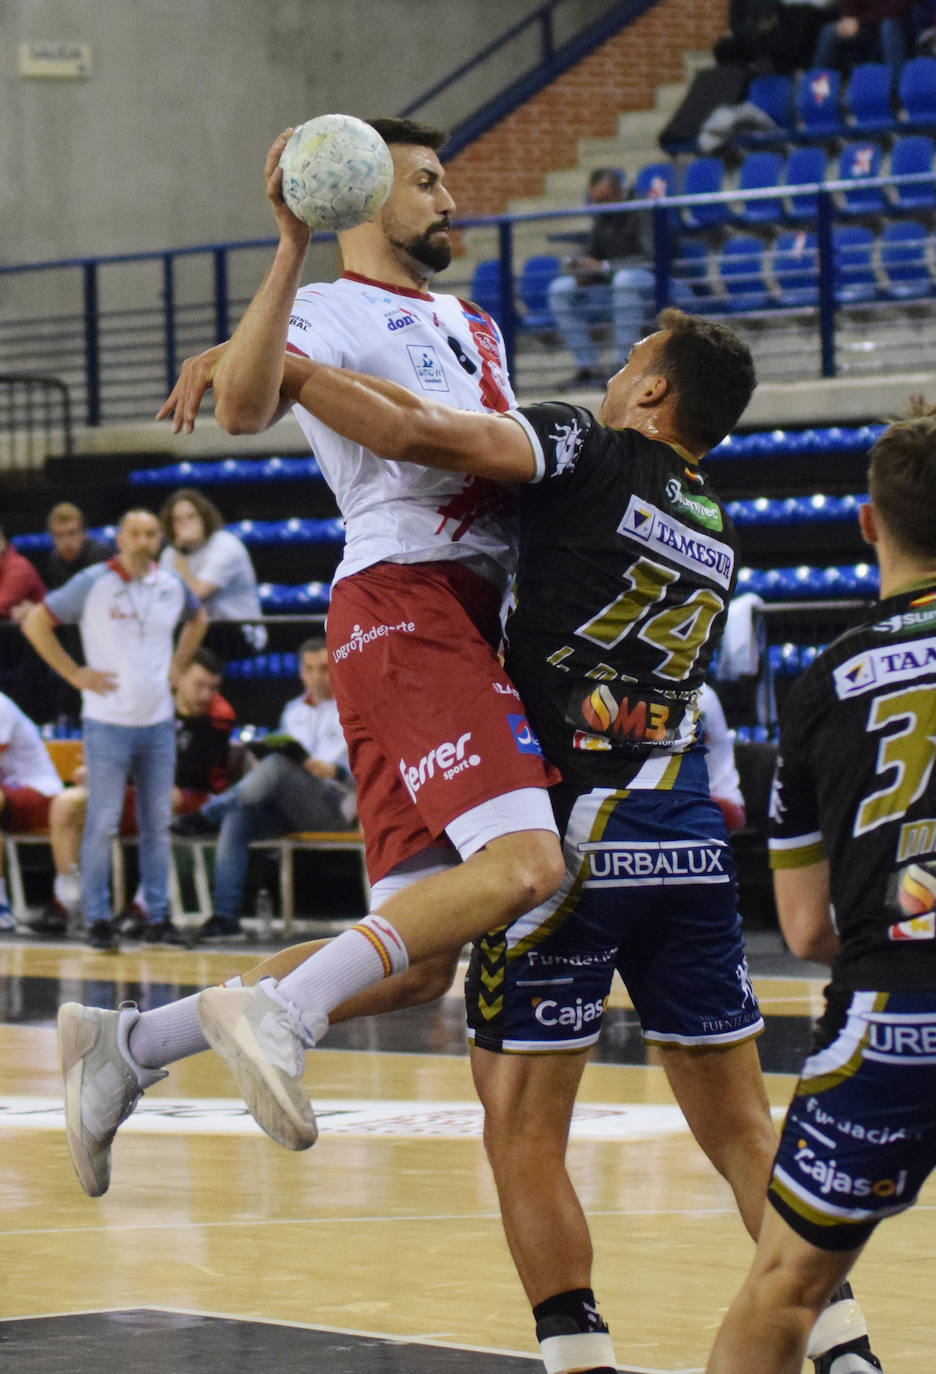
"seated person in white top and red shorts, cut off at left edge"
0,692,63,930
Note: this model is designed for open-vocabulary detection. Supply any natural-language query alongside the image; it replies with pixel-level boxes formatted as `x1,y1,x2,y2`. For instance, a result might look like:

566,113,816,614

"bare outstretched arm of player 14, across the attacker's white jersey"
282,354,535,482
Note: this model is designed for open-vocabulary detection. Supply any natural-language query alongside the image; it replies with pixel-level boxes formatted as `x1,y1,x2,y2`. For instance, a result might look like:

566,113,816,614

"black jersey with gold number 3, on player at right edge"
770,584,936,992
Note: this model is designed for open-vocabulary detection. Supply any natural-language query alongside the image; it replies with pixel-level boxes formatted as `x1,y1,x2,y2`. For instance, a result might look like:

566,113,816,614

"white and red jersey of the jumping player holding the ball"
287,273,515,591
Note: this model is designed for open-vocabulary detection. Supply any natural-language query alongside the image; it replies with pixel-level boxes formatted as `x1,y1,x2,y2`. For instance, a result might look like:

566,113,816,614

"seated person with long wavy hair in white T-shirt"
159,486,267,654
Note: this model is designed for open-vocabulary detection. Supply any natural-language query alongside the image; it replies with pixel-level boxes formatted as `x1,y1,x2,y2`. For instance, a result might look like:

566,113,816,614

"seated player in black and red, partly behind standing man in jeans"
30,649,242,938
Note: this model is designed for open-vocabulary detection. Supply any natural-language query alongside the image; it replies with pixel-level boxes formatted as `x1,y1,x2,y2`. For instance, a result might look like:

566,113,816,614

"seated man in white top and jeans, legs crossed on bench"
172,638,356,940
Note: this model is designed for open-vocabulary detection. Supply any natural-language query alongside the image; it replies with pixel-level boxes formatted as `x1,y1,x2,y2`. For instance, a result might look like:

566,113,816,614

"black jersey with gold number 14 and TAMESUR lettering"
506,403,735,787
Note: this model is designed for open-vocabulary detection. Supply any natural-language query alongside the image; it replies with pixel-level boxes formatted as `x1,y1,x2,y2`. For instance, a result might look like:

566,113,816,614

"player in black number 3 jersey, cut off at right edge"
708,414,936,1374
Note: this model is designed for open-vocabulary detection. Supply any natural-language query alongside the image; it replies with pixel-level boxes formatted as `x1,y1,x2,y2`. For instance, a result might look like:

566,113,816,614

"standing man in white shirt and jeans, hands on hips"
22,510,208,949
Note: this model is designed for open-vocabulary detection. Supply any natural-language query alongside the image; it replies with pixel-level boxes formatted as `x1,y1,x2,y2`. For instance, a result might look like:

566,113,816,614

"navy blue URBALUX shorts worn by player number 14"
466,780,763,1054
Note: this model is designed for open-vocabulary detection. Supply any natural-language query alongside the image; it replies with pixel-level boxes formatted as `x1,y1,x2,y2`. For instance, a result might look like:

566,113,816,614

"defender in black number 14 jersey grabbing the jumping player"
270,311,863,1374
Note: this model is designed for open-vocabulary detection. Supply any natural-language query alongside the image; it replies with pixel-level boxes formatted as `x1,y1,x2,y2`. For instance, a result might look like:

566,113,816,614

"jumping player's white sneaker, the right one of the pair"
198,978,328,1150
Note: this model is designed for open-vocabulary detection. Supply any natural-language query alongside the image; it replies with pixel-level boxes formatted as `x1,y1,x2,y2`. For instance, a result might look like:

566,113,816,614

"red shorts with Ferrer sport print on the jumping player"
326,562,559,882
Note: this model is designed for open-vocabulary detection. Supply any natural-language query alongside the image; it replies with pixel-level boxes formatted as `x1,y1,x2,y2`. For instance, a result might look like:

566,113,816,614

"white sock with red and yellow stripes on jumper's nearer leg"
276,911,410,1014
